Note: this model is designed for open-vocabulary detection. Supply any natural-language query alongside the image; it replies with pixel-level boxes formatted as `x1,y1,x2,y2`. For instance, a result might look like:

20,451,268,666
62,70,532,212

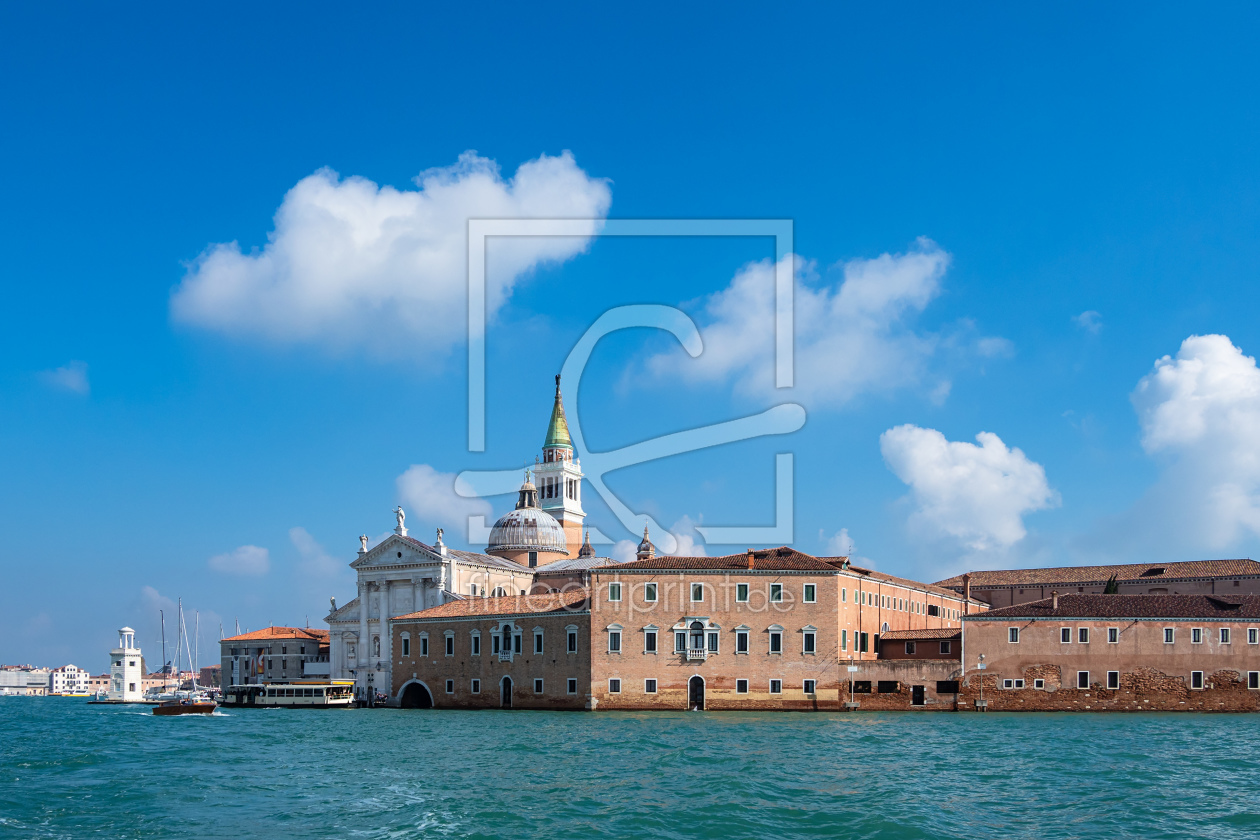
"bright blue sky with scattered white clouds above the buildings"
7,4,1260,670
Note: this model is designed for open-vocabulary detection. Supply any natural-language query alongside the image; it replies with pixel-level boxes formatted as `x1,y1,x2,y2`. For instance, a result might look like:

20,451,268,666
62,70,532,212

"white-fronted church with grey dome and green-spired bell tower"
325,377,630,694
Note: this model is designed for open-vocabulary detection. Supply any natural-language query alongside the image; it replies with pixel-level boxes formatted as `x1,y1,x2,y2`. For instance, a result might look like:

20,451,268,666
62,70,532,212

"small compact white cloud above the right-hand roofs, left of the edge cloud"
879,424,1058,552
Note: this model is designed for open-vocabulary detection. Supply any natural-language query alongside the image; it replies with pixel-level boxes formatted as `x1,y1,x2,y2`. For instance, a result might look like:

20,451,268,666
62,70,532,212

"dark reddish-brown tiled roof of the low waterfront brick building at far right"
977,594,1260,622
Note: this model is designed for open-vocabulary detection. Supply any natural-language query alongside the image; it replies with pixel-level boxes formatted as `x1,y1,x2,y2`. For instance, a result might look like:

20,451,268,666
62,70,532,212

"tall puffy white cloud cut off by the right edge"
1131,335,1260,548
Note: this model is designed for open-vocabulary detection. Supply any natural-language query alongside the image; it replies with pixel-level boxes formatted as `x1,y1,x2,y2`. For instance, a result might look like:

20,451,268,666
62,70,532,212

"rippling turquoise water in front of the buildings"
0,698,1260,840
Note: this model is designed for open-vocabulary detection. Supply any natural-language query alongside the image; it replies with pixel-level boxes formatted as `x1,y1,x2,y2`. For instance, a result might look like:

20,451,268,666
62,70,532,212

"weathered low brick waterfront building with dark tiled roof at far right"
961,594,1260,712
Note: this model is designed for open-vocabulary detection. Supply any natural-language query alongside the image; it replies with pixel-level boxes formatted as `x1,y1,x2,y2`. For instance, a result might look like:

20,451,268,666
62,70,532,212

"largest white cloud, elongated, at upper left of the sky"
171,151,611,359
